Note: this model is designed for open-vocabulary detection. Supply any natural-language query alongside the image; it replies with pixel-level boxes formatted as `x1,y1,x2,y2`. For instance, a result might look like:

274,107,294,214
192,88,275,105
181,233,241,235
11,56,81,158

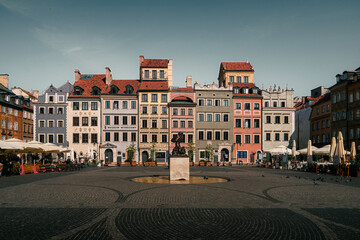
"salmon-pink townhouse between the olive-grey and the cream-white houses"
232,83,262,164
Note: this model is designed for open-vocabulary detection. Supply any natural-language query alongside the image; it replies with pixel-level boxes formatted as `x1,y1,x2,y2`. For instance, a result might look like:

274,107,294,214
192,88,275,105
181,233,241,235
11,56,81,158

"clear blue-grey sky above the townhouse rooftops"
0,0,360,96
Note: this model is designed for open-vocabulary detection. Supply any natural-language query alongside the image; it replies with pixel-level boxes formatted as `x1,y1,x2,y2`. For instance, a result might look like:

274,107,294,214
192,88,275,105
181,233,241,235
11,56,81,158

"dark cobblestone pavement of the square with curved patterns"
0,166,360,239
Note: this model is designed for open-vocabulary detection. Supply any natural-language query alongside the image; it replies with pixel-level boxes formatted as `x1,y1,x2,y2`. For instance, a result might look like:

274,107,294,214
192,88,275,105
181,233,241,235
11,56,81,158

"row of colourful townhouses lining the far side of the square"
35,56,294,164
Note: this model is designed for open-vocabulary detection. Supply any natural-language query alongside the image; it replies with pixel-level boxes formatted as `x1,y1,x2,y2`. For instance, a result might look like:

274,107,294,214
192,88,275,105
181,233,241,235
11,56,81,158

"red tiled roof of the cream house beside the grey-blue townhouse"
69,74,107,97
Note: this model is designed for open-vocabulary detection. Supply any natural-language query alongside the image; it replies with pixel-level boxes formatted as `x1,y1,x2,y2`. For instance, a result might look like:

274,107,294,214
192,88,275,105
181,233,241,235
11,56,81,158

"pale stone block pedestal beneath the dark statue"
170,157,190,181
